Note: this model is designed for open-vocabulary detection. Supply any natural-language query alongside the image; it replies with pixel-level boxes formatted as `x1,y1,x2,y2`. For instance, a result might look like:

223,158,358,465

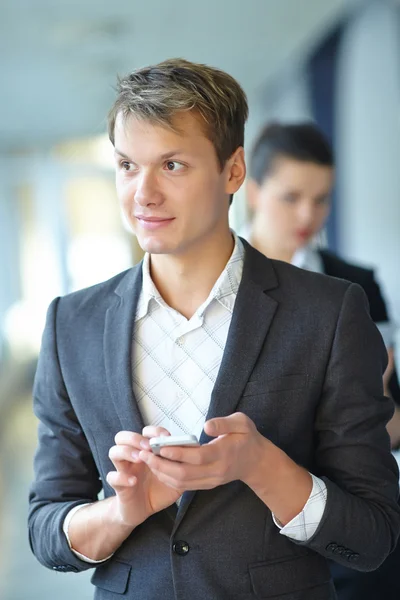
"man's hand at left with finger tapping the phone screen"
107,427,182,526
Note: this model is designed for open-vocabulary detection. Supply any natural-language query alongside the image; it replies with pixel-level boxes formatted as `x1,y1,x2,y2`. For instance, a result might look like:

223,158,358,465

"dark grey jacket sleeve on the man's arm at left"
28,299,101,571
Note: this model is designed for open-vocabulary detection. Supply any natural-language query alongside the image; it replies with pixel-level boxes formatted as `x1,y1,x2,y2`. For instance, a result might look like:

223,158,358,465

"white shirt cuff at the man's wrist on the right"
272,473,328,542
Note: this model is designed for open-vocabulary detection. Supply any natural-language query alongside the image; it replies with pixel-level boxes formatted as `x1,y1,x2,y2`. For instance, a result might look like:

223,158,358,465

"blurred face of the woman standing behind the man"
248,157,334,253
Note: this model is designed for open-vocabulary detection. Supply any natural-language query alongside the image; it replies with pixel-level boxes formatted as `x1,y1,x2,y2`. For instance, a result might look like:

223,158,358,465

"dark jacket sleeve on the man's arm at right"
296,284,400,571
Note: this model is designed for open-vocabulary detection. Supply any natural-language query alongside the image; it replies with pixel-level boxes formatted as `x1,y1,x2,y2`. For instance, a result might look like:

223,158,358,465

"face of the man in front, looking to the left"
115,112,241,255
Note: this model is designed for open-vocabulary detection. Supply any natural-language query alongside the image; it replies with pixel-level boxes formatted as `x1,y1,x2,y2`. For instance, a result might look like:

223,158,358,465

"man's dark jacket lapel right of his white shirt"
174,240,278,532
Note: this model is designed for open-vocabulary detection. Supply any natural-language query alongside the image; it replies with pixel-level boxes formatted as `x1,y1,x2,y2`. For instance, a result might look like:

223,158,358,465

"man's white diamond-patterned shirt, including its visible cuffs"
64,236,327,563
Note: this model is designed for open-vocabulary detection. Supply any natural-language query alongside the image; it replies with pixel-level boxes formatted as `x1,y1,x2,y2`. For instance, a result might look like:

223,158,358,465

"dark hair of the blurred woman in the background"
249,122,334,185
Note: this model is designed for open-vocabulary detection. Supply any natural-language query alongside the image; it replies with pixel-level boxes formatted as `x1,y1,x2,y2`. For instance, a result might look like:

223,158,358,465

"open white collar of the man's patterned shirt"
136,231,245,321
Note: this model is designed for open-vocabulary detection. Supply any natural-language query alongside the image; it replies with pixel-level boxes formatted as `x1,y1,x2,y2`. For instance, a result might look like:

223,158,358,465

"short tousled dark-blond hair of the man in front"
108,58,248,169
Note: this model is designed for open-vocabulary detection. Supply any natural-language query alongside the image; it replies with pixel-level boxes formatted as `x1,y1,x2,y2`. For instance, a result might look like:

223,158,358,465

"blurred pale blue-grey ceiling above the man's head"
0,0,360,151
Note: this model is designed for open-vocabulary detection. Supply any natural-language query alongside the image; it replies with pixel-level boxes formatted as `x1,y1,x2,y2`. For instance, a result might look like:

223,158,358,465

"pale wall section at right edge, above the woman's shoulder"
337,0,400,348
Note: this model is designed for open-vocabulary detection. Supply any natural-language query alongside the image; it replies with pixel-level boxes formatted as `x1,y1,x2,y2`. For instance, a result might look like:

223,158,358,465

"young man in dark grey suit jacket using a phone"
29,60,400,600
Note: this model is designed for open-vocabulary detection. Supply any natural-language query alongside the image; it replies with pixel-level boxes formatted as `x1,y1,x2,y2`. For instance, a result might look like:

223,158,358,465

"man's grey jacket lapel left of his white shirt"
103,263,144,432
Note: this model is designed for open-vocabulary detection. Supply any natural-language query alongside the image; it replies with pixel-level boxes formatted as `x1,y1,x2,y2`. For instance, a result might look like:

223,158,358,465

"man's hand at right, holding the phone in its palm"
134,413,312,525
